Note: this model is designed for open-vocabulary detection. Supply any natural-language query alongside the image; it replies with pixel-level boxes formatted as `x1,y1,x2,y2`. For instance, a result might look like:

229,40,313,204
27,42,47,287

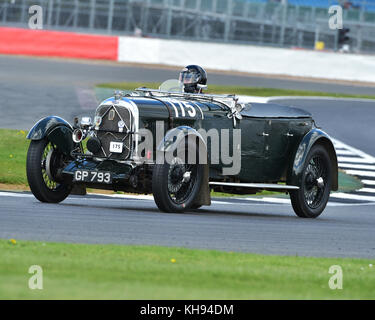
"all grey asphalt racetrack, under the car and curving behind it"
0,56,375,258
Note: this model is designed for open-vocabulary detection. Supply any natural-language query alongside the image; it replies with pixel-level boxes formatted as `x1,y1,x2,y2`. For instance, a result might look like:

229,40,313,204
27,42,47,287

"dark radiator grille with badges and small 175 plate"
95,106,132,160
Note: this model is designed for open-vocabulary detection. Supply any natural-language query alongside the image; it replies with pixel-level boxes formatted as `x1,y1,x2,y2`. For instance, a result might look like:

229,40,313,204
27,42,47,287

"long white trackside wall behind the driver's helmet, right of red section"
118,37,375,82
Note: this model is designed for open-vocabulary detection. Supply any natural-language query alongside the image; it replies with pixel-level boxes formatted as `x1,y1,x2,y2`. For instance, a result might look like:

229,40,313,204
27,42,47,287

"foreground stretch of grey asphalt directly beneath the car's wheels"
0,193,375,258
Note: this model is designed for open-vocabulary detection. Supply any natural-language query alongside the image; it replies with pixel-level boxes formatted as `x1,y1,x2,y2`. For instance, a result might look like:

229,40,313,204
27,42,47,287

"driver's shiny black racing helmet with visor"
179,65,207,93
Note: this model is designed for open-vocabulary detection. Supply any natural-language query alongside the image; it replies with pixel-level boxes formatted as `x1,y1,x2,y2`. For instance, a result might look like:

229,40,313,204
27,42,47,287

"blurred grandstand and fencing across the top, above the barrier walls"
0,0,375,53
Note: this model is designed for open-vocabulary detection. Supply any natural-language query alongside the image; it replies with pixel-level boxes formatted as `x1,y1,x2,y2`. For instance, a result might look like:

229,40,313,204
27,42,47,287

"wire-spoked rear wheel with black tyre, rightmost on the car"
290,145,332,218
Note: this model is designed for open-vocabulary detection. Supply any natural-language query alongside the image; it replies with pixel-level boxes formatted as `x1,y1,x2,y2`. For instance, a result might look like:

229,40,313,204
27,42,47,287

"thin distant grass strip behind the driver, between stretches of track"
97,82,375,99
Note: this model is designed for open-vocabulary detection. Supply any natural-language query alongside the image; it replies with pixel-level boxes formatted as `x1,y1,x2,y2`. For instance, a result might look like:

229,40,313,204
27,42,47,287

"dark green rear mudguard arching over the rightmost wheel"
287,128,338,191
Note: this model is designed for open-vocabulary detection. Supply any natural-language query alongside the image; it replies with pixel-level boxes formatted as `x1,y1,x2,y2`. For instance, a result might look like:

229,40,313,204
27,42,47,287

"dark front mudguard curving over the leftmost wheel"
26,116,76,155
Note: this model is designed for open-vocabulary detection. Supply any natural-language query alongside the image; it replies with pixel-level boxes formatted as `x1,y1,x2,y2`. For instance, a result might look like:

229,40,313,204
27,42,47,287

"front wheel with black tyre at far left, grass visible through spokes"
26,139,72,203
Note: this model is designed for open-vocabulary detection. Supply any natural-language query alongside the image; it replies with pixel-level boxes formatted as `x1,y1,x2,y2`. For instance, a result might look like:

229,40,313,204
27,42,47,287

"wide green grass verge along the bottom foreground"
0,240,375,299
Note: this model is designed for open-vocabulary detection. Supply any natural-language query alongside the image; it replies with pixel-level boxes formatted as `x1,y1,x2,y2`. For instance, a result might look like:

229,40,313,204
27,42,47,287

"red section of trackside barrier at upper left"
0,28,118,60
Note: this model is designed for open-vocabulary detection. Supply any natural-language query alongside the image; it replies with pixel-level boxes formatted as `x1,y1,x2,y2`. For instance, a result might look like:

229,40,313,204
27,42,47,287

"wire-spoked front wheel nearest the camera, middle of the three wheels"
152,143,204,212
